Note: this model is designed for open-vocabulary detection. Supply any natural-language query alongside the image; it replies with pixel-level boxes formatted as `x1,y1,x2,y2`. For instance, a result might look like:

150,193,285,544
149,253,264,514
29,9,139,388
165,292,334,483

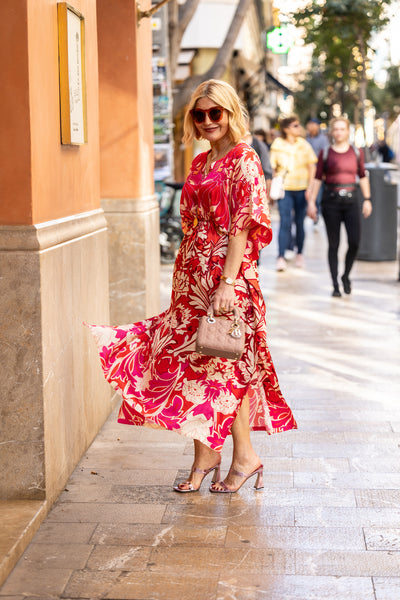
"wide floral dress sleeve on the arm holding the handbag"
229,147,272,260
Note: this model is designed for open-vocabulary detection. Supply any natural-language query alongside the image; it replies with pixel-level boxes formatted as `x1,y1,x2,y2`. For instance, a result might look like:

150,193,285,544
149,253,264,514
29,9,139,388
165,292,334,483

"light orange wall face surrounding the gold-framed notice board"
28,0,100,223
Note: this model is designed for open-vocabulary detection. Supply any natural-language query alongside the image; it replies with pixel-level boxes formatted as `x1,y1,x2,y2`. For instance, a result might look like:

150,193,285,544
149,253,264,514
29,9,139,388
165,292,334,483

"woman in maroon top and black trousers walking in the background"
308,117,372,297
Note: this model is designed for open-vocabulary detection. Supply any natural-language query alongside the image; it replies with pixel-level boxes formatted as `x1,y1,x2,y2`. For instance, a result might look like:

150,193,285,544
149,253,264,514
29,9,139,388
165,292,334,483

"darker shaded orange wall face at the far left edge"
0,0,32,225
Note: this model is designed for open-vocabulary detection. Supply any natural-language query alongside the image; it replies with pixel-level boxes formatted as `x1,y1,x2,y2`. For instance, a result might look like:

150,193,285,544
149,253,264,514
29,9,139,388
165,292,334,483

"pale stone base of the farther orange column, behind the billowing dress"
102,196,160,325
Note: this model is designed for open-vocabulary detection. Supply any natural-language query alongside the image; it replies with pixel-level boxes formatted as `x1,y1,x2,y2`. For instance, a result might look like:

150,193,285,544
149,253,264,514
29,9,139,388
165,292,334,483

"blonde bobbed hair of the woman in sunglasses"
182,79,247,145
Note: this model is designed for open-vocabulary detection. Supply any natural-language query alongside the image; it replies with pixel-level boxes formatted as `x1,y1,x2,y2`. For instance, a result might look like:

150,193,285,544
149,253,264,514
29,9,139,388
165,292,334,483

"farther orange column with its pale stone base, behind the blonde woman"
97,0,160,324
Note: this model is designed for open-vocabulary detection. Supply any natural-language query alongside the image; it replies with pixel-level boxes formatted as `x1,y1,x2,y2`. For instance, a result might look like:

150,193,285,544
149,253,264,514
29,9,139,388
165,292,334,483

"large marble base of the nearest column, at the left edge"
0,210,112,505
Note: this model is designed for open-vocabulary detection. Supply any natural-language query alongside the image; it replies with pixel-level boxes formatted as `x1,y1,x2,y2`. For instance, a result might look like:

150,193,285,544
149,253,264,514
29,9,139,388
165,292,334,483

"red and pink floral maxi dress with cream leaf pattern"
91,143,297,451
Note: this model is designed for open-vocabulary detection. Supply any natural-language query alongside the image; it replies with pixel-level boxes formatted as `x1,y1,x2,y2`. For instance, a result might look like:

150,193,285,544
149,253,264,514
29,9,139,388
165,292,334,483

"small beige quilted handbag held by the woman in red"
196,307,245,360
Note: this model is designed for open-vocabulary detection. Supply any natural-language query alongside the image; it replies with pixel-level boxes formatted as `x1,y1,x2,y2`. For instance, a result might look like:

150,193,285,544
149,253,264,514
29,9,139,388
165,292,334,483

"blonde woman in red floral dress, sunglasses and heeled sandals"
87,80,296,493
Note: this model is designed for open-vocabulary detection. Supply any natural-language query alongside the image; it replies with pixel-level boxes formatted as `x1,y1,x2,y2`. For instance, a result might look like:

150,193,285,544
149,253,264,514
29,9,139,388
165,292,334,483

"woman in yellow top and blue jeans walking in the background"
270,115,317,271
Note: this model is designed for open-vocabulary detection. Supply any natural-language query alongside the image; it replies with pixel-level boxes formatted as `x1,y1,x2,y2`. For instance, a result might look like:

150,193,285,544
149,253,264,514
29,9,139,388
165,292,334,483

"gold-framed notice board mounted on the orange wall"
57,2,87,145
